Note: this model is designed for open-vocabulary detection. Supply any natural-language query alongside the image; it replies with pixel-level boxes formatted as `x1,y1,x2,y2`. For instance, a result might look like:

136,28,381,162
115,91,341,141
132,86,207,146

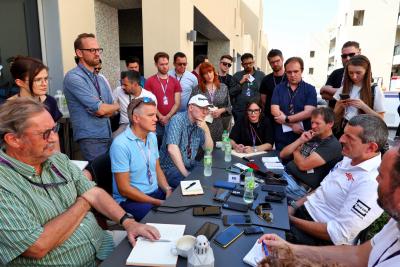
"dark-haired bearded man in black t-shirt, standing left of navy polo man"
260,49,286,123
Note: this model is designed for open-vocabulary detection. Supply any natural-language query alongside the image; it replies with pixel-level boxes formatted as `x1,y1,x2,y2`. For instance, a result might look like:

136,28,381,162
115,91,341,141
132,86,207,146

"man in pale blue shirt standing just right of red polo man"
168,52,198,111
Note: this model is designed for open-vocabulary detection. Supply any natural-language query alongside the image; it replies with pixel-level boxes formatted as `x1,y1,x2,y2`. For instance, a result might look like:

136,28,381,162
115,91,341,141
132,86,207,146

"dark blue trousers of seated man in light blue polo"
119,188,165,221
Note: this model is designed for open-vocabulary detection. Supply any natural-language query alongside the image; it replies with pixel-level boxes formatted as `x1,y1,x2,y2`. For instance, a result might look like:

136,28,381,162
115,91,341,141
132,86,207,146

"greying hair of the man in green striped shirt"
0,97,46,147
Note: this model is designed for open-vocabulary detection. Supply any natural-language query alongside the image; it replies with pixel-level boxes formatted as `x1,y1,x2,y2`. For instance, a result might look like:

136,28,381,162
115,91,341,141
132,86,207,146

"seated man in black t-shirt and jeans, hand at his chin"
279,107,342,200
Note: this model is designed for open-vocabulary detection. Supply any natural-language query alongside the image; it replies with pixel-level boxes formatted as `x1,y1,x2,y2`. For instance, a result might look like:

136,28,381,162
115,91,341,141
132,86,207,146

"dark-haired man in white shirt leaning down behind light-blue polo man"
113,70,157,137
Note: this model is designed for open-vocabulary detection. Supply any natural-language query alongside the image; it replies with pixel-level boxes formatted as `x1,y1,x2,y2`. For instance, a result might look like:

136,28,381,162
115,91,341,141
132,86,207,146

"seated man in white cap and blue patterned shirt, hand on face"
160,94,214,188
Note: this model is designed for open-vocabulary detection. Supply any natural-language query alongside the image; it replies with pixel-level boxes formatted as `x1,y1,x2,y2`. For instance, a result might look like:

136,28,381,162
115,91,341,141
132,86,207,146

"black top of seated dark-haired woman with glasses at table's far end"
229,117,274,146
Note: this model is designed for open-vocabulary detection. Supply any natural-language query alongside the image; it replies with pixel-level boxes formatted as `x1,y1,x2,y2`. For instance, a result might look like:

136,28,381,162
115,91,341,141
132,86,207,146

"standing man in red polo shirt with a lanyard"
144,52,182,144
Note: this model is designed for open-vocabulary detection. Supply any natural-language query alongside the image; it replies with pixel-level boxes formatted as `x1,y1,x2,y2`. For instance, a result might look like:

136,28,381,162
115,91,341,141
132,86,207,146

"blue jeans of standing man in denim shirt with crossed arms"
78,138,112,162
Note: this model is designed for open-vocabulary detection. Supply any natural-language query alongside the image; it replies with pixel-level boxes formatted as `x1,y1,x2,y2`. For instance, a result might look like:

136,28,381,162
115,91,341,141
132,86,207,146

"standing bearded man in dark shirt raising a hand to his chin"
232,53,265,121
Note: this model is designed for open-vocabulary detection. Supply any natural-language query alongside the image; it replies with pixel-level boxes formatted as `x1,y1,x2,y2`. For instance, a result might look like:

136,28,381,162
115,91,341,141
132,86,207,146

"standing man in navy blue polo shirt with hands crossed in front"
271,57,317,151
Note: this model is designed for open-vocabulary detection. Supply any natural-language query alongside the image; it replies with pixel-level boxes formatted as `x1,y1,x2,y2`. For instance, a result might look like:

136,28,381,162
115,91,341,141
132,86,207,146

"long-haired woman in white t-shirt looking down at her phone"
334,55,385,138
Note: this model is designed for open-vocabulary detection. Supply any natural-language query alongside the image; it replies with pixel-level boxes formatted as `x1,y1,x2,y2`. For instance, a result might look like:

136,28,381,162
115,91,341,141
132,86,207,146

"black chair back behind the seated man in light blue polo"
88,152,112,195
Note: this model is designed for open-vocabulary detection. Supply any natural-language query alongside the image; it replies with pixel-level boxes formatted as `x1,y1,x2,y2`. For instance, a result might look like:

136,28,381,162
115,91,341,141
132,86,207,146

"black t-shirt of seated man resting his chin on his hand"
286,135,343,189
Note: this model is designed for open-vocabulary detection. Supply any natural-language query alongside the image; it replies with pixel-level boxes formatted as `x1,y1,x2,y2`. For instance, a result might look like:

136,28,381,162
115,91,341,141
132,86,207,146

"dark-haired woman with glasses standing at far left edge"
8,56,63,151
